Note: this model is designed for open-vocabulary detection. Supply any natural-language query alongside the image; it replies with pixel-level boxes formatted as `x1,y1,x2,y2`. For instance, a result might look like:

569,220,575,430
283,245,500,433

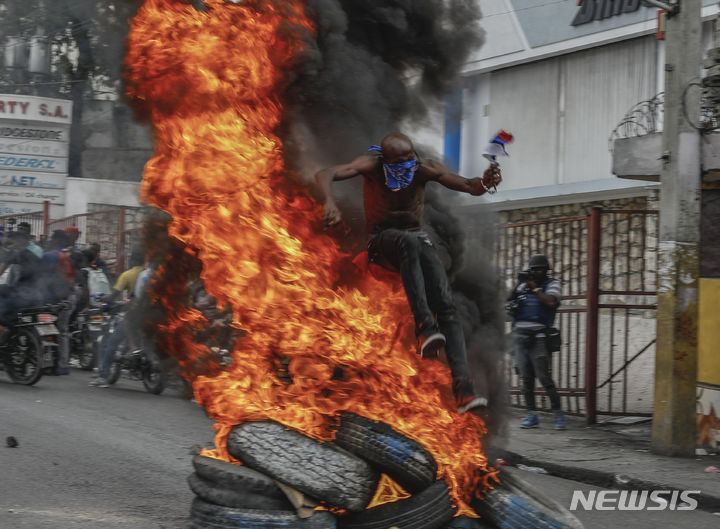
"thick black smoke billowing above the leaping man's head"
285,0,483,163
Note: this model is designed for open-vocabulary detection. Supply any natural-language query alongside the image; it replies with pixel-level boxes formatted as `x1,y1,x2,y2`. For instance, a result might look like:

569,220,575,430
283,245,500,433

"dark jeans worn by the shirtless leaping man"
368,229,475,396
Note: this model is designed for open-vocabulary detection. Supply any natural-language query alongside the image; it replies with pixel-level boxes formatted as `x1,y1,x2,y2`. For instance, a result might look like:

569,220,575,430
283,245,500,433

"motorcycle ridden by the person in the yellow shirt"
101,312,167,395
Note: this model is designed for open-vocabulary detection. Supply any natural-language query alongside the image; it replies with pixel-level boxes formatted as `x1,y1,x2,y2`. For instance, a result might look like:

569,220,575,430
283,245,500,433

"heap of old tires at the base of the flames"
184,414,580,529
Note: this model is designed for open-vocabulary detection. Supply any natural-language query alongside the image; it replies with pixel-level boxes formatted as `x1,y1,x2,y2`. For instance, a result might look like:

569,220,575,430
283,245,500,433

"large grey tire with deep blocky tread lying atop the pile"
227,421,379,512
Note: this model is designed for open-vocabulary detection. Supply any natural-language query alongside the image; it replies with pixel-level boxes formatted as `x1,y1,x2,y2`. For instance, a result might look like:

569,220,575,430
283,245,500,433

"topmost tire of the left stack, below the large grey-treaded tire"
193,456,287,501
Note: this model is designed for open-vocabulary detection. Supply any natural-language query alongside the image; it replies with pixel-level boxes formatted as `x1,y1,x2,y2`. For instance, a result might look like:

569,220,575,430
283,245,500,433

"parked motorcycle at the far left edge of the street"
0,305,62,386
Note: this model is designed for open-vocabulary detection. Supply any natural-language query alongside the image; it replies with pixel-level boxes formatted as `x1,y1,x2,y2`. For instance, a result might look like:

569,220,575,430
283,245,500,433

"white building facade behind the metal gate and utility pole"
434,0,720,420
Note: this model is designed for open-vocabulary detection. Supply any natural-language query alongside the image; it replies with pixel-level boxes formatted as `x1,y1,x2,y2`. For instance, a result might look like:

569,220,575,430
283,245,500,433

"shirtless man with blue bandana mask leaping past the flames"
315,133,501,413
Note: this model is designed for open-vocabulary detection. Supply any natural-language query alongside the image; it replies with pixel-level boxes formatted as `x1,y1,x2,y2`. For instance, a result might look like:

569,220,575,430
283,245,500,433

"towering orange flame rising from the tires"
126,0,493,513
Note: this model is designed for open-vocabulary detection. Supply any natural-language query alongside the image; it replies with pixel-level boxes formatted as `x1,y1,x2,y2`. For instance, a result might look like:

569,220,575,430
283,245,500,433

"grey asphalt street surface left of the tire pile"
0,370,214,529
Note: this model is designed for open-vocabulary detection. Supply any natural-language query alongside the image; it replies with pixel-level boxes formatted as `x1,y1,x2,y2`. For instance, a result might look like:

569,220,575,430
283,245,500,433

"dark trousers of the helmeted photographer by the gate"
513,330,561,411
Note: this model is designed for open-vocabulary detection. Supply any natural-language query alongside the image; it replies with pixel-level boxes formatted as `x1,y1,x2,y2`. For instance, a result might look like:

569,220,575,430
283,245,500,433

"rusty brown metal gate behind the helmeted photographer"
497,208,658,423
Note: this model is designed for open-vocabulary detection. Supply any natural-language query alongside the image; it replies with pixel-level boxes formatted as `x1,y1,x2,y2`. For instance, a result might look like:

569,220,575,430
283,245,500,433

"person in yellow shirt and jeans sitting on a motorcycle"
89,250,145,388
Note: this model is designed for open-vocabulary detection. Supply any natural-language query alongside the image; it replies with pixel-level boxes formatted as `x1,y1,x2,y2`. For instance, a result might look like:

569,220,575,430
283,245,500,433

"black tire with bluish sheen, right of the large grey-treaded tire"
335,413,437,493
